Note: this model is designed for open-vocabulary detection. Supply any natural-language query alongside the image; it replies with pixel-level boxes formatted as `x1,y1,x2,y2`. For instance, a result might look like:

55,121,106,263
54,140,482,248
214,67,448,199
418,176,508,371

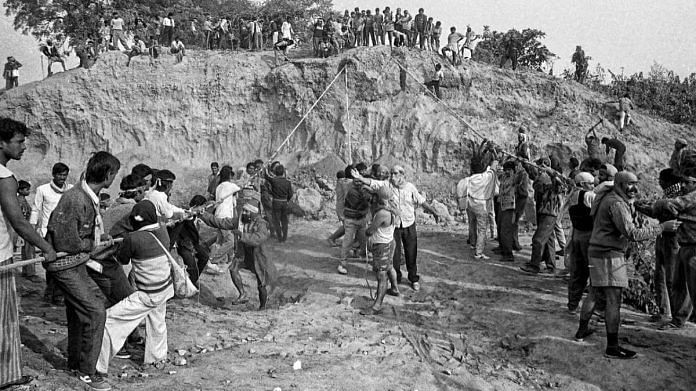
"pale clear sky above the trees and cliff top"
0,0,696,82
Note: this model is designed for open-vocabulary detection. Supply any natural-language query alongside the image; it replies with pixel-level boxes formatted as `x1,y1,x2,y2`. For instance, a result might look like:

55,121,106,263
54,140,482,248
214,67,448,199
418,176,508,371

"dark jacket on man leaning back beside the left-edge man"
46,185,97,272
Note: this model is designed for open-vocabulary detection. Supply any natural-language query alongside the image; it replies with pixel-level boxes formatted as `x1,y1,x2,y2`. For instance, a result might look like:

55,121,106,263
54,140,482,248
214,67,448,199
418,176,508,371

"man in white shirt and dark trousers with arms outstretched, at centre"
352,166,432,291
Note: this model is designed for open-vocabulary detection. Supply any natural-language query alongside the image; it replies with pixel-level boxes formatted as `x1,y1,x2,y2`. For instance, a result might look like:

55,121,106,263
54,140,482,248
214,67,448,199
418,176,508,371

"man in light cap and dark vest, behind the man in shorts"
567,172,595,313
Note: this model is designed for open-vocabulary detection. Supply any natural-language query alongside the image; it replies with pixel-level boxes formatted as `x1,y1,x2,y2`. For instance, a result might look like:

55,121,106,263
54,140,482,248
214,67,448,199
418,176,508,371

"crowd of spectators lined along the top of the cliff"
16,7,486,77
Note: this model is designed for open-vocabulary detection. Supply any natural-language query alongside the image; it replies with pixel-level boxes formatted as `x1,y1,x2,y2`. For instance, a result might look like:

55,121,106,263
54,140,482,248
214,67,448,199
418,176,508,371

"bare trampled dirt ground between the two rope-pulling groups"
9,221,696,391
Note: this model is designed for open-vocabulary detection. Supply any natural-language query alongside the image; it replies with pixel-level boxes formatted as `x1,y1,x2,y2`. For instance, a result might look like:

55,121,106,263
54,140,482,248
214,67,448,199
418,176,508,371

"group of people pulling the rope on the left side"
0,118,293,390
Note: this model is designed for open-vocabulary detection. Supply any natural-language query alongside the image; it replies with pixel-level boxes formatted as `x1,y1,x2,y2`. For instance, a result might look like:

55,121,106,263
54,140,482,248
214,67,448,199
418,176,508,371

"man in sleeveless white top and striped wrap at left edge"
0,118,56,389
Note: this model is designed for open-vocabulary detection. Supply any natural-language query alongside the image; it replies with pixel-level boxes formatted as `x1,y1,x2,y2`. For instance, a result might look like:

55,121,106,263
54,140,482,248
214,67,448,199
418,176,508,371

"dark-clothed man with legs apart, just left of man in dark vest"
520,158,566,274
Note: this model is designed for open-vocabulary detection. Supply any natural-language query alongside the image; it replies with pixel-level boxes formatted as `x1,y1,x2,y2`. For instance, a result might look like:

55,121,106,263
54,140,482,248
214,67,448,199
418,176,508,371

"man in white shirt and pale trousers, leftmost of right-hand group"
457,160,498,259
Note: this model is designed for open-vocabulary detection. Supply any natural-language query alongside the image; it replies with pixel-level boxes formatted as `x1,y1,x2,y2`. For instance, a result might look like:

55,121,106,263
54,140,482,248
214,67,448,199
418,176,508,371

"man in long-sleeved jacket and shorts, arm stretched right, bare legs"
575,171,680,359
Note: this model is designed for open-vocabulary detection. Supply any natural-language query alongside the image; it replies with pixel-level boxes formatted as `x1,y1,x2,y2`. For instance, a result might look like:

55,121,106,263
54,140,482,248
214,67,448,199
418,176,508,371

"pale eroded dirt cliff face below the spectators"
0,47,696,199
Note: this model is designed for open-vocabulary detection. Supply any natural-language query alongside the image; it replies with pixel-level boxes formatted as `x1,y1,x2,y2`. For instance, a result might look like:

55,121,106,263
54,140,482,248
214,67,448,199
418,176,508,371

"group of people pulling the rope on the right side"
457,120,696,359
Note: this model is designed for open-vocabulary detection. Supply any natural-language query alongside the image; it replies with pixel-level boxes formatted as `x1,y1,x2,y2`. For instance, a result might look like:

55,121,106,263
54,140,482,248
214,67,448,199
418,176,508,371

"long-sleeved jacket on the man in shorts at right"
590,191,662,252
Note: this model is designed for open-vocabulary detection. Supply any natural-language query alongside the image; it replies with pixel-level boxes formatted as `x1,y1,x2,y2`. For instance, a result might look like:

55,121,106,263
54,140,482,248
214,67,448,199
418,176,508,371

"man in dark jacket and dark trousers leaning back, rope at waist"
45,151,121,390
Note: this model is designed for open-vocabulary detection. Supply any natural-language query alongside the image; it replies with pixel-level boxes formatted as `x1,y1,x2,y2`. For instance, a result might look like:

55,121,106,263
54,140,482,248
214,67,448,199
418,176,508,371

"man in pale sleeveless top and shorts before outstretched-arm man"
360,188,399,315
